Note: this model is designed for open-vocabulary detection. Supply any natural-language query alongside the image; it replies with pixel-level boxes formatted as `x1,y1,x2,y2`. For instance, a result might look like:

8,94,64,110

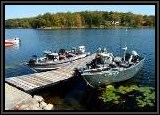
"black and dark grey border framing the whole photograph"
0,0,159,114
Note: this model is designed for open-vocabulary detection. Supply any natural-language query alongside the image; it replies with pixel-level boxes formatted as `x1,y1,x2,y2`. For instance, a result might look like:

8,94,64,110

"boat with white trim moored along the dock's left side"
27,46,90,71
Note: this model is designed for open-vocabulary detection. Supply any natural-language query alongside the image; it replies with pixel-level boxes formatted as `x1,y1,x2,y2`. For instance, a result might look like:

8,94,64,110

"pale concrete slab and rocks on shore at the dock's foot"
5,83,54,110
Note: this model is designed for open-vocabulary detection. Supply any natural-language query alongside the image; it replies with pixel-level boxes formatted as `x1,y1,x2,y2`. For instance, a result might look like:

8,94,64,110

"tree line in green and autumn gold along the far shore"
5,11,155,28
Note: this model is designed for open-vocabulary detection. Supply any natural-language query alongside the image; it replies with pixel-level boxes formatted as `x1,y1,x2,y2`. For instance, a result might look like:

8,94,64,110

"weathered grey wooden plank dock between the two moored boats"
5,54,95,91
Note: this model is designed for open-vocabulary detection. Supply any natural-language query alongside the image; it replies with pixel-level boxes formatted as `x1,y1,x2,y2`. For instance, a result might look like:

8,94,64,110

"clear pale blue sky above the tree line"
5,5,155,20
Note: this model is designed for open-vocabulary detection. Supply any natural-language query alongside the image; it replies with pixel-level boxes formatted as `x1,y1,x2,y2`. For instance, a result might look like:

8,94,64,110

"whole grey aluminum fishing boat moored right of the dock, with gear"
80,47,145,87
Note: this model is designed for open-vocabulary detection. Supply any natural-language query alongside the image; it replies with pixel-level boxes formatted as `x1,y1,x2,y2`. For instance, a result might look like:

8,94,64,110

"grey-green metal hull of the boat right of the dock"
82,59,145,87
